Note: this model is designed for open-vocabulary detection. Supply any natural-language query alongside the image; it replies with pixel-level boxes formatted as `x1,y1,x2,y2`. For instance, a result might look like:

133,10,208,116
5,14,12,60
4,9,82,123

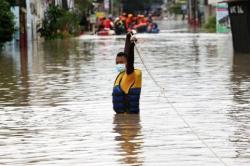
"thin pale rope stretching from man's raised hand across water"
134,42,228,166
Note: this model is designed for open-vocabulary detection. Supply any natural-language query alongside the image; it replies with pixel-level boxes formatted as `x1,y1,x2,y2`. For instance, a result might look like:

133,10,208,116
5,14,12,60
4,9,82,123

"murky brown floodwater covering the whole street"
0,21,250,166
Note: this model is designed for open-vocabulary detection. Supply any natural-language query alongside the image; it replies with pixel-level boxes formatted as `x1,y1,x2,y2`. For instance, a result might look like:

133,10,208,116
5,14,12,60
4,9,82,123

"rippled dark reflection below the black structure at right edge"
229,54,250,159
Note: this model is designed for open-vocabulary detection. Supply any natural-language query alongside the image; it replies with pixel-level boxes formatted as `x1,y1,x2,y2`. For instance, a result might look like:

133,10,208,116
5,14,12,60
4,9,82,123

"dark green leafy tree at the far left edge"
0,0,15,47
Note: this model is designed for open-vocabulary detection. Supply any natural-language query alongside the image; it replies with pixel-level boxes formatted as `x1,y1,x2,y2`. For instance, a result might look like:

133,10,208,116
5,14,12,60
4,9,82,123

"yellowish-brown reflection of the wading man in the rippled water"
114,114,143,165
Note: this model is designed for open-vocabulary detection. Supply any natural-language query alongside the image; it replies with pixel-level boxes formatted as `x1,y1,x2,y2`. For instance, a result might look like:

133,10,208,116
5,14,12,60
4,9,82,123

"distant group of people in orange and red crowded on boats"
97,13,159,35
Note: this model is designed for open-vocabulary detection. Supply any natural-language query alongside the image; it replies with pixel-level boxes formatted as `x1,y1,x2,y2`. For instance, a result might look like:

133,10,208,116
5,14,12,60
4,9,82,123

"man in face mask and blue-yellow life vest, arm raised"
112,32,142,114
